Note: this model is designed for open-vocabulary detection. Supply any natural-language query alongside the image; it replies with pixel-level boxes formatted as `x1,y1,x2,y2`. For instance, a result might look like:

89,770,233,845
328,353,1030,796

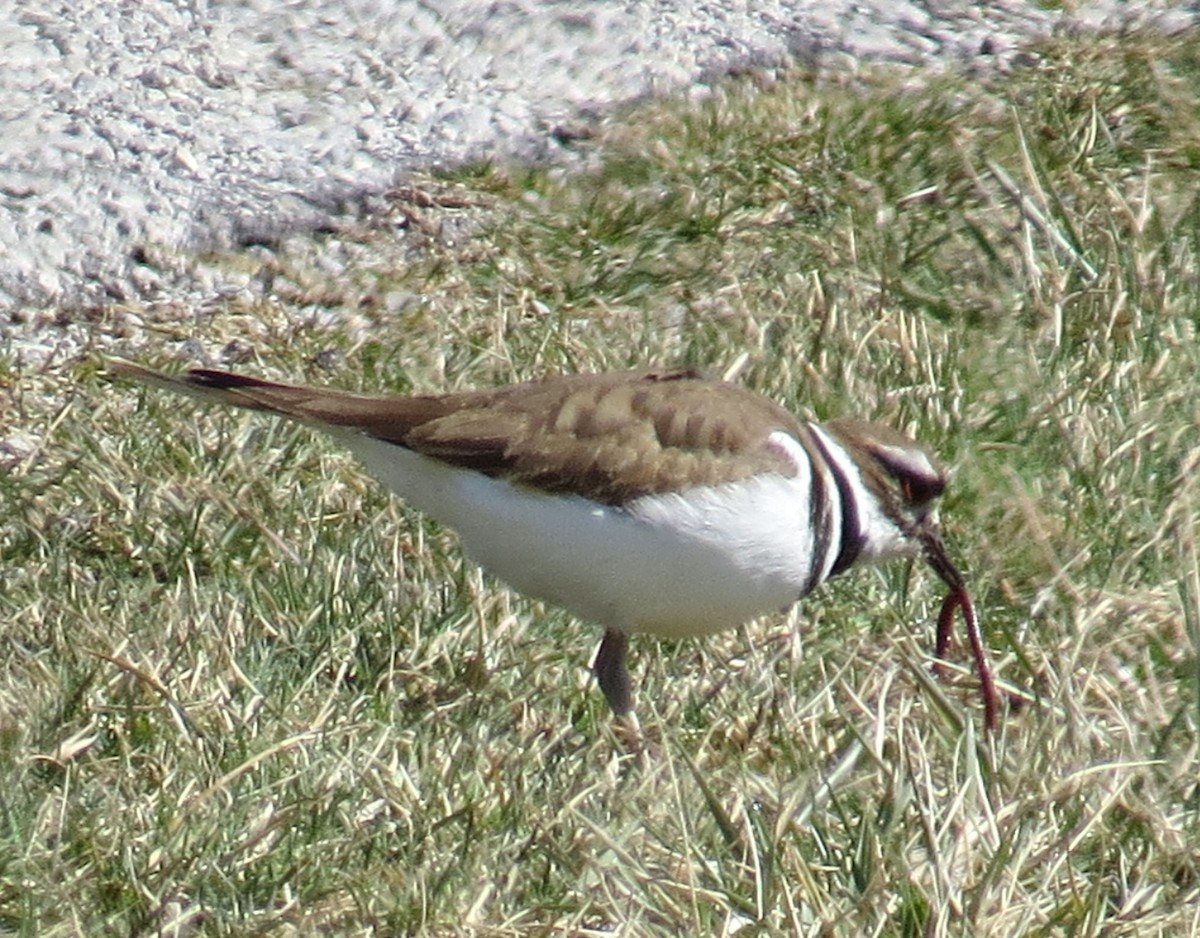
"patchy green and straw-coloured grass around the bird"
0,25,1200,936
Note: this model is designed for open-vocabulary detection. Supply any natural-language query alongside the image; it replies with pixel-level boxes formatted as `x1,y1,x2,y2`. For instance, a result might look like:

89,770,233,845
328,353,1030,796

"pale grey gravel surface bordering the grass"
0,0,1200,324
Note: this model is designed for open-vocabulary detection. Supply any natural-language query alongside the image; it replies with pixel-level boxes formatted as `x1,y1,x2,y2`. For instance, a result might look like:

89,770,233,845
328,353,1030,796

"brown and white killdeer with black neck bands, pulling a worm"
112,361,997,727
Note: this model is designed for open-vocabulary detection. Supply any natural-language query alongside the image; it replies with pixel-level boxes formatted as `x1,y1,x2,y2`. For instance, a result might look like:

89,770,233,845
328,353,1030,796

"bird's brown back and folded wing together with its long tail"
112,362,806,504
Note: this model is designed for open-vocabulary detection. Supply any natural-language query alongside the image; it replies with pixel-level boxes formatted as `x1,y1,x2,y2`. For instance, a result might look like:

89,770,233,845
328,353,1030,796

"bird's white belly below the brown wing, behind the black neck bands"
340,434,827,636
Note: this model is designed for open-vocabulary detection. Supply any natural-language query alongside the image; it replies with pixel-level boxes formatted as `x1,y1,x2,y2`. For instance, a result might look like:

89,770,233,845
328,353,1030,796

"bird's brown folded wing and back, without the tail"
403,372,803,504
